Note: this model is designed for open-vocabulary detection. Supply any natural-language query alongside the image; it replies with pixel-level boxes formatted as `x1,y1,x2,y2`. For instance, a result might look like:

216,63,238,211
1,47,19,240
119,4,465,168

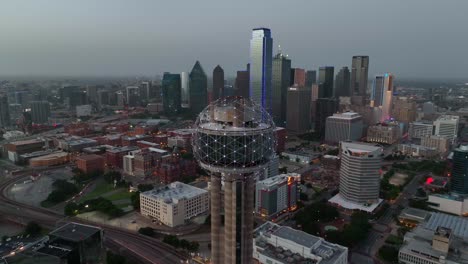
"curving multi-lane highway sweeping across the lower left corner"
0,176,188,264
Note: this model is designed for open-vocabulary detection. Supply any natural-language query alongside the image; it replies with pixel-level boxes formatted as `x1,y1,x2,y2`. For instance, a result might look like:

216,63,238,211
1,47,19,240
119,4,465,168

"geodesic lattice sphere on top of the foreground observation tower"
192,97,276,172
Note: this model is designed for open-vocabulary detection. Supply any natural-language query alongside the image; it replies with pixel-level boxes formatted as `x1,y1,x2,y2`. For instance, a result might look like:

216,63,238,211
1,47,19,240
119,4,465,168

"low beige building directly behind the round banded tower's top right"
366,122,402,145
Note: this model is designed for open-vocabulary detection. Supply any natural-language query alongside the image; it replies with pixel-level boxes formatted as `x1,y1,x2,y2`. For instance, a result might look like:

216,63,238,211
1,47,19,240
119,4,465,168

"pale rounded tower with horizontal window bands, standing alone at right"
339,142,383,204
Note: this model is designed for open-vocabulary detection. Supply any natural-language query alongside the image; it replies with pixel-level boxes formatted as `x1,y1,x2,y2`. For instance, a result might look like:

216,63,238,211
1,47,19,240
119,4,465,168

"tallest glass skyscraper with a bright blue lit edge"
249,28,273,113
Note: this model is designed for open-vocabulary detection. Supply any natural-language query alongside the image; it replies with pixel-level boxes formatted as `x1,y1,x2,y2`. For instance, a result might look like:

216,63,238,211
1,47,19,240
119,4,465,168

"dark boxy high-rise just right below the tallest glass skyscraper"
286,87,312,133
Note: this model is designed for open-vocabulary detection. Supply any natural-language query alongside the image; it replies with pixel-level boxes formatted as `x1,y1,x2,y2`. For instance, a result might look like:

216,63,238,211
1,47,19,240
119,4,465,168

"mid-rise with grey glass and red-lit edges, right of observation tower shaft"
255,173,301,220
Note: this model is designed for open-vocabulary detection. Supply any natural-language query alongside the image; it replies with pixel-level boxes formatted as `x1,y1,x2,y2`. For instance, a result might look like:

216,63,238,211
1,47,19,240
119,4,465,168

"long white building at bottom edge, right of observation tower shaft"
253,222,348,264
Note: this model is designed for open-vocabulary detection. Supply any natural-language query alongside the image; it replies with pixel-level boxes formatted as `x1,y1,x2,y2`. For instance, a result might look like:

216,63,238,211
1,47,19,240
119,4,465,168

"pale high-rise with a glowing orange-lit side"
371,73,393,122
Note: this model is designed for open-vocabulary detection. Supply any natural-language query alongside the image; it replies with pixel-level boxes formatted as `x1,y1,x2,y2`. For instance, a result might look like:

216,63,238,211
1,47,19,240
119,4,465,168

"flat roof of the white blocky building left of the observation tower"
141,182,208,203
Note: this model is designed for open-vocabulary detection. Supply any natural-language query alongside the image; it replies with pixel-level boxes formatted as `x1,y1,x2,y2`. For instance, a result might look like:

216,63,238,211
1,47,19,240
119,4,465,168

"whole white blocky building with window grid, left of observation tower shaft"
140,182,209,227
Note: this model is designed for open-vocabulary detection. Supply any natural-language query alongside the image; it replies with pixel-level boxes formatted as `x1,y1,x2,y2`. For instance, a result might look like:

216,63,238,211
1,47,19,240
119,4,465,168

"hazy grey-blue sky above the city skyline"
0,0,468,78
